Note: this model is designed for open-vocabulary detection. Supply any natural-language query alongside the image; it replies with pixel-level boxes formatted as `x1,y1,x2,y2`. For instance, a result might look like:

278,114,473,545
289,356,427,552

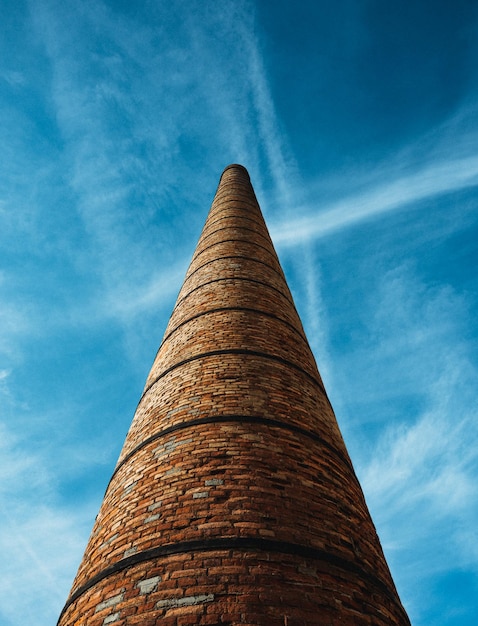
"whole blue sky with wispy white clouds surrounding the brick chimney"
0,0,478,626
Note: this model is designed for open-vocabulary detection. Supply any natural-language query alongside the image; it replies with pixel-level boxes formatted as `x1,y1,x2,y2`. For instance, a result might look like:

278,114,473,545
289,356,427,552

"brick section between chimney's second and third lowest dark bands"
120,354,336,459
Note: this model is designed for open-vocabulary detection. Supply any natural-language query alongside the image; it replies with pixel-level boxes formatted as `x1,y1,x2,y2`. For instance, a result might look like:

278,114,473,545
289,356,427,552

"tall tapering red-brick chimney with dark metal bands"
59,165,410,626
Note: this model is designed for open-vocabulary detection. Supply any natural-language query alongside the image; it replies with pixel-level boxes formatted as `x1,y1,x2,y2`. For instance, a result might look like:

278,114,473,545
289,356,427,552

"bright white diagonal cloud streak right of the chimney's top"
271,95,478,248
